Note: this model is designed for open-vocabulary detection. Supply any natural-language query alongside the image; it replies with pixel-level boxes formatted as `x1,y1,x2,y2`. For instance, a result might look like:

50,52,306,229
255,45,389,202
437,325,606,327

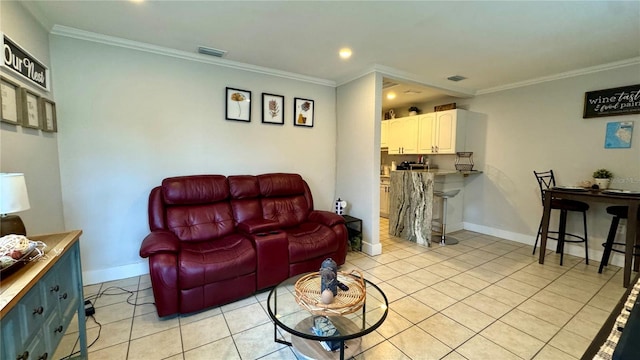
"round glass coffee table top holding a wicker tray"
267,274,389,340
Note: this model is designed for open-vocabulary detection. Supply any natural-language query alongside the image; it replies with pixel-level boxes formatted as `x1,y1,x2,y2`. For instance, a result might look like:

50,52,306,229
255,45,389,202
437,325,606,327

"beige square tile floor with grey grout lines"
55,219,625,360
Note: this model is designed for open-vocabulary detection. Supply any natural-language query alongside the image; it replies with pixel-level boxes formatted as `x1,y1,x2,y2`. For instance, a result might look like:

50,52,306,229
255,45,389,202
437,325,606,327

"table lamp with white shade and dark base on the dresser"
0,173,31,236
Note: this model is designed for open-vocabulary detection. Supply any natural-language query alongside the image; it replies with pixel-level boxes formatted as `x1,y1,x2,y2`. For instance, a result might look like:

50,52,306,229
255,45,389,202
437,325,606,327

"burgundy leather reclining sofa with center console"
140,173,347,317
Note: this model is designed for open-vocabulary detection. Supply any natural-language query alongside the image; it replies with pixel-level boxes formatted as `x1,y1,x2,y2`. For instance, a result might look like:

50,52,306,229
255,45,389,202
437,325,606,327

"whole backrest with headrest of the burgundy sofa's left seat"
161,175,235,241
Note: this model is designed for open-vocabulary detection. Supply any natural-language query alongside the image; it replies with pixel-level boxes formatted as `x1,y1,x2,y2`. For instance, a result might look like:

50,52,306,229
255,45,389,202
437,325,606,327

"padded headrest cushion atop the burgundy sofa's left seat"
162,175,229,205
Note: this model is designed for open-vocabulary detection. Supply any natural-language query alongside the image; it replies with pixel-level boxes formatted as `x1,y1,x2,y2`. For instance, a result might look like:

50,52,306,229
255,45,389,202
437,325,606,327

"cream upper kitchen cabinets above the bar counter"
381,109,467,154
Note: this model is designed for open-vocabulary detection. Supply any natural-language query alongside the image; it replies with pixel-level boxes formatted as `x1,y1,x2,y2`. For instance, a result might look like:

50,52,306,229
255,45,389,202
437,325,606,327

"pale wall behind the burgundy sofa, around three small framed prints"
51,35,336,283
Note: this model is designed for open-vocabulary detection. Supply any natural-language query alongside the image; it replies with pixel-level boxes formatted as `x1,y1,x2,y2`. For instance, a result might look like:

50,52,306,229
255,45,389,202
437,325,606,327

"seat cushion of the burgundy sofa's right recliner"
286,222,338,263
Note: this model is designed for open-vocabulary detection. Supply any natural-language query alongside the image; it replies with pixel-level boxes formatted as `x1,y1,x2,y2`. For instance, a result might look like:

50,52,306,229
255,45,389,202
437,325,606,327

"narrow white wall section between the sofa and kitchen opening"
336,73,382,255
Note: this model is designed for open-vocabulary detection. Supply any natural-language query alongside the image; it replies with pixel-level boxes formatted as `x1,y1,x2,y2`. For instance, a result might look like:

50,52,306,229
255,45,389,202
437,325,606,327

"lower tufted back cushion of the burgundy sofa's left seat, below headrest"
166,202,235,241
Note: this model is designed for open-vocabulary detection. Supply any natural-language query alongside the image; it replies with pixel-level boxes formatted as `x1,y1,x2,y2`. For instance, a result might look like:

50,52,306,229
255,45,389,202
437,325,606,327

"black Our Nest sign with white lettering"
2,35,49,90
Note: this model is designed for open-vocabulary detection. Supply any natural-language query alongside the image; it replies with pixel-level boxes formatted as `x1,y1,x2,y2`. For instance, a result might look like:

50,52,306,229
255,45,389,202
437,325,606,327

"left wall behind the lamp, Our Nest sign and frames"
0,1,64,236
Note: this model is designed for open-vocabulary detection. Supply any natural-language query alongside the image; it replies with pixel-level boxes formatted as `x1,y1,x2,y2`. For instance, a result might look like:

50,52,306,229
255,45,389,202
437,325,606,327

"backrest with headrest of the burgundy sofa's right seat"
257,173,313,228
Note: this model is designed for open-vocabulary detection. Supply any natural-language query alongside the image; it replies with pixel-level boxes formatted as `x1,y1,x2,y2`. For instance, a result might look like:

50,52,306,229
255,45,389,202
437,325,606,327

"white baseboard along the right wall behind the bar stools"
464,223,624,267
